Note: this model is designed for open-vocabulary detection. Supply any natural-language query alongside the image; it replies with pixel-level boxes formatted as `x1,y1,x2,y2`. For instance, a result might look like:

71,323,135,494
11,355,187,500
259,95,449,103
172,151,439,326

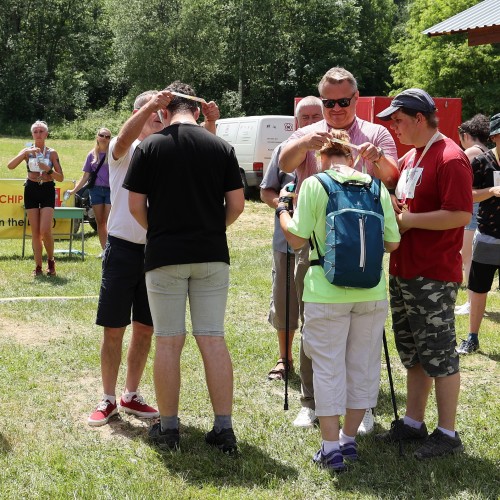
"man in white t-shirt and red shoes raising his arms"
87,90,219,426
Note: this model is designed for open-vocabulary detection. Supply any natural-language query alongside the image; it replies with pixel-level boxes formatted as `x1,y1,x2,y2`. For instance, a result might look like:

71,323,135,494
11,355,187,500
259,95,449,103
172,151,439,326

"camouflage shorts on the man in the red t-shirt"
389,276,459,377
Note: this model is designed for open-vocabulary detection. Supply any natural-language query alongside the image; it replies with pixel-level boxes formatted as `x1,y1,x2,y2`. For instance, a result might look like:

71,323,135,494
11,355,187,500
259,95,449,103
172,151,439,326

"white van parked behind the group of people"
216,115,295,199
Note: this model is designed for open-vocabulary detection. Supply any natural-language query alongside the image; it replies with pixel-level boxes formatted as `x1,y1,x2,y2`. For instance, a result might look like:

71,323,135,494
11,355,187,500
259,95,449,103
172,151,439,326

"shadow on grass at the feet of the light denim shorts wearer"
143,424,298,488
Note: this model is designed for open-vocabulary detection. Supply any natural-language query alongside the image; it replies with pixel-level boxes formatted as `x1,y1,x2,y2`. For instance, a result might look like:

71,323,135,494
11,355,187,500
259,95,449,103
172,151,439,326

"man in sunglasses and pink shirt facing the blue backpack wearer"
279,67,399,434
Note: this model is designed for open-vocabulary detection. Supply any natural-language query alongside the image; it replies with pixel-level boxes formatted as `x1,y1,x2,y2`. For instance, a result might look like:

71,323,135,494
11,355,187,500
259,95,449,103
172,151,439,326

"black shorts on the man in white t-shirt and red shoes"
96,235,153,328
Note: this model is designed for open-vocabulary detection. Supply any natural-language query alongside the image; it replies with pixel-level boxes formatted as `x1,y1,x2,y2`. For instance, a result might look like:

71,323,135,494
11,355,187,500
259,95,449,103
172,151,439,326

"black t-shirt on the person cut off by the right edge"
471,151,500,238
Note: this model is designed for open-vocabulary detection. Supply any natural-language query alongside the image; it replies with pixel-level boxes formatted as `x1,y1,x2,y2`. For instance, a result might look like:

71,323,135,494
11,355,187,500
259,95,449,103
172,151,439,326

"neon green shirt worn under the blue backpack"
288,169,401,304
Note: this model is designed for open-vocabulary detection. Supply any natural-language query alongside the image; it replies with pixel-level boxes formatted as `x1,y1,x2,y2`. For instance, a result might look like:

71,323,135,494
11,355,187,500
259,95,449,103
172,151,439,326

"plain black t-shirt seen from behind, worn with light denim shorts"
123,123,243,271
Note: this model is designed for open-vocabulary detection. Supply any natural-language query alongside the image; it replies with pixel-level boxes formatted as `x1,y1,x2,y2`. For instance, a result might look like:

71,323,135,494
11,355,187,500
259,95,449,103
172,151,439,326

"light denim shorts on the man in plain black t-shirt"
146,262,229,337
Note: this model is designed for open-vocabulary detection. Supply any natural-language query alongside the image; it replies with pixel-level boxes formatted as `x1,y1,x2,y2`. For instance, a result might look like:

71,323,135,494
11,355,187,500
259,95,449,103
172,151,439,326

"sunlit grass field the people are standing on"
0,139,500,499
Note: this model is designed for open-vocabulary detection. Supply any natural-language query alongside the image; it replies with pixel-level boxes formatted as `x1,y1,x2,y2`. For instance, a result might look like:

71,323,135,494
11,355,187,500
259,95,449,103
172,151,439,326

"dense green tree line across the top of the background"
0,0,500,137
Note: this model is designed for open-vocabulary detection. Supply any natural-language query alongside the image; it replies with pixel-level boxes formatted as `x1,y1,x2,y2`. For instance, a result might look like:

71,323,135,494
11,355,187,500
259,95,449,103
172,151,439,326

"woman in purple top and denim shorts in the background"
69,128,111,249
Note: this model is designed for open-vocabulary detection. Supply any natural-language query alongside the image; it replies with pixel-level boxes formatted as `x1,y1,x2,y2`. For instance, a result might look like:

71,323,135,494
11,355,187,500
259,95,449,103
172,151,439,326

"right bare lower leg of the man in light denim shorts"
196,335,233,415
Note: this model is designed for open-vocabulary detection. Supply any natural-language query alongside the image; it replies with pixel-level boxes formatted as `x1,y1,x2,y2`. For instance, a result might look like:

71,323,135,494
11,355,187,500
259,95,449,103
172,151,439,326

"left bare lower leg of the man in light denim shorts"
154,335,186,417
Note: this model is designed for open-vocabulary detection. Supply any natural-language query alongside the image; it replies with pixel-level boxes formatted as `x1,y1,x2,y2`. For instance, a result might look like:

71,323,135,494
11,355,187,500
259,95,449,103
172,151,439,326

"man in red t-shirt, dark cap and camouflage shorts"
377,89,472,459
